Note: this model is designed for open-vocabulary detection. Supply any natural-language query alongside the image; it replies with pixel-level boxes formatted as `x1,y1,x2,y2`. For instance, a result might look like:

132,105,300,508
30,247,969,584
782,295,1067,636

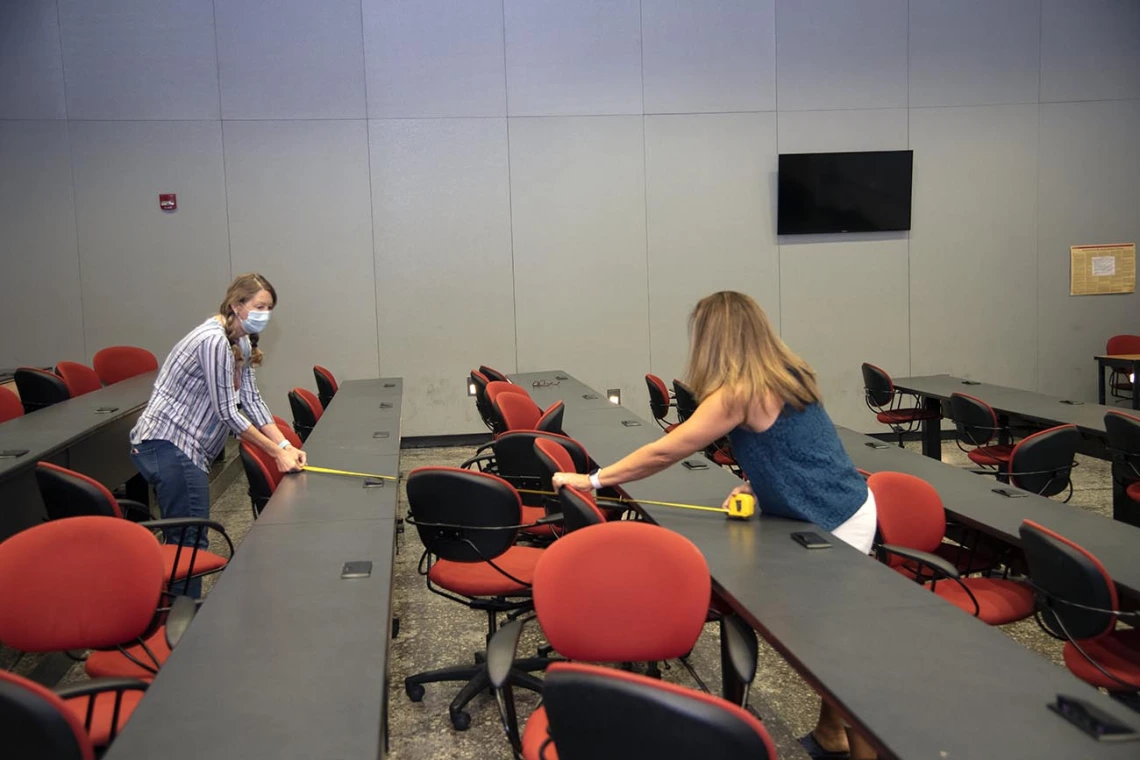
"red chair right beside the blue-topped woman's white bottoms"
868,472,1033,626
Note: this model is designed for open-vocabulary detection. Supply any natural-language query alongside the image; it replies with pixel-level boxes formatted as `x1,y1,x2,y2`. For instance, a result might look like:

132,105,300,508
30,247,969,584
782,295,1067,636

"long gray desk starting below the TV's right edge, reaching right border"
895,375,1140,525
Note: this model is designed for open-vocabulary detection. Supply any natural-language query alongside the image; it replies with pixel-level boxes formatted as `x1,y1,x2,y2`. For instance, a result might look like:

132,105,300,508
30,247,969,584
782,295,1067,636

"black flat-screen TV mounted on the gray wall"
776,150,914,235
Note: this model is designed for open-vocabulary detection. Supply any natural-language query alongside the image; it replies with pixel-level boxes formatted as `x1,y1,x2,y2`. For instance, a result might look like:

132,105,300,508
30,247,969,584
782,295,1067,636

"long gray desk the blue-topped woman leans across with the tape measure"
513,370,1140,759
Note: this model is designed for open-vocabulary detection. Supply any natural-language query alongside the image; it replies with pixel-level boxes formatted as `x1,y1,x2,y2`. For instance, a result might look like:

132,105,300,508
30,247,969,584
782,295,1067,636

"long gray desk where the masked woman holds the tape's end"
106,378,402,760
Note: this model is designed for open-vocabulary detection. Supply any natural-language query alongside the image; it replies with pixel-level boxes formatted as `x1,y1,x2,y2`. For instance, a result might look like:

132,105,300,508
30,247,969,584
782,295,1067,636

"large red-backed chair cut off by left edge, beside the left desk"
0,517,194,742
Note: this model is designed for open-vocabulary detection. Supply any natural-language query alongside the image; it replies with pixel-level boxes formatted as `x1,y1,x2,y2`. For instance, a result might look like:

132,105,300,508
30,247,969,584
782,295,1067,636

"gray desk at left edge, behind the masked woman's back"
0,373,157,541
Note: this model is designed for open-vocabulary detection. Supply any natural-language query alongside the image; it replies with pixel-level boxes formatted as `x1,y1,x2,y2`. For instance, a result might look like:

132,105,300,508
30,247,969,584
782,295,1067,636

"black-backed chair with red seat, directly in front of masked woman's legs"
35,461,234,610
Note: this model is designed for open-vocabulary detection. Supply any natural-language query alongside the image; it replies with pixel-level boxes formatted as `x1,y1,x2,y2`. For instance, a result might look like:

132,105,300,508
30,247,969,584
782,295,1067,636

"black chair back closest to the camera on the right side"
1018,520,1117,640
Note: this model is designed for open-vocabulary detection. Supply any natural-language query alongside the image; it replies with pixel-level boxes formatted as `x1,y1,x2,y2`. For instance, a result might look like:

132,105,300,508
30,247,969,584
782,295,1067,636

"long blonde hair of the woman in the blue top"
685,291,821,409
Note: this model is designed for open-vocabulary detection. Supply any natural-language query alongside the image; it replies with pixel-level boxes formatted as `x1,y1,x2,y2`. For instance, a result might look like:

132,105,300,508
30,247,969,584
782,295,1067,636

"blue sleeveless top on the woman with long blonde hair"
728,403,868,531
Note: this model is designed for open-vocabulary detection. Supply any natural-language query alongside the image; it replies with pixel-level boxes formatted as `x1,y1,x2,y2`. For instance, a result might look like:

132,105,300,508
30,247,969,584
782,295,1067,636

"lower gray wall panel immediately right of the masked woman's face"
225,120,378,417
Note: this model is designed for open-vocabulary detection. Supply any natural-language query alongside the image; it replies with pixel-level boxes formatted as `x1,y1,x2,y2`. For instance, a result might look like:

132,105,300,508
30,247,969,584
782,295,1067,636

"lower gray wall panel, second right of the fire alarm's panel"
369,119,515,435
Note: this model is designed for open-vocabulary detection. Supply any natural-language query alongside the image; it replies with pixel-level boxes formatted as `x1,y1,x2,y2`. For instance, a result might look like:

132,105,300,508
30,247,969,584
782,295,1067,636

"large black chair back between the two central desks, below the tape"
407,467,522,562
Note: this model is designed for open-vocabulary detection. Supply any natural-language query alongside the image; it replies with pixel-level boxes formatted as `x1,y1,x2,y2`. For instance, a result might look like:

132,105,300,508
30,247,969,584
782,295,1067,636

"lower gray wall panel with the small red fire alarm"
71,121,229,359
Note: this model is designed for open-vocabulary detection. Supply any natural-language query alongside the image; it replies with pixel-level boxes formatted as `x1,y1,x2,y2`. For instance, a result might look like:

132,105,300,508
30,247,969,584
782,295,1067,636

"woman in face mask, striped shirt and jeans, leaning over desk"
131,273,306,597
